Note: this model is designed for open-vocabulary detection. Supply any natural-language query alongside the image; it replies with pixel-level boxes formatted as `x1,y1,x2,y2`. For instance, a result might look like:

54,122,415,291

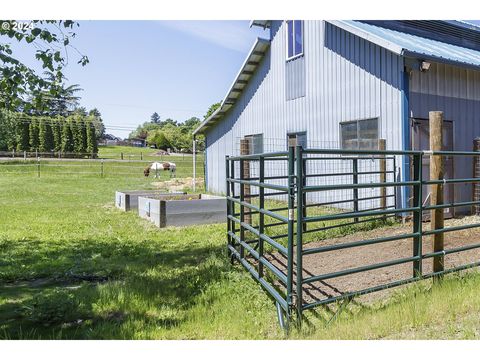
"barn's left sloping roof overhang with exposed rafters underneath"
193,38,270,135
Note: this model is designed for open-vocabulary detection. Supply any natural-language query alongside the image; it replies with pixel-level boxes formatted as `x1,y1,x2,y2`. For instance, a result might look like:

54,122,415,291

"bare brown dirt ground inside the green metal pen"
269,216,480,303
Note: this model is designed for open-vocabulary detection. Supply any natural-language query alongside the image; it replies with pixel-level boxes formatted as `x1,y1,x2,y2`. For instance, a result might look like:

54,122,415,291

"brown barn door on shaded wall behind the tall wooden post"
412,119,455,220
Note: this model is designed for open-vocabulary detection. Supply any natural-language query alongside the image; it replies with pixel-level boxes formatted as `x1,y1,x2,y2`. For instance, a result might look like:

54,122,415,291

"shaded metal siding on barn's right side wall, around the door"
410,63,480,208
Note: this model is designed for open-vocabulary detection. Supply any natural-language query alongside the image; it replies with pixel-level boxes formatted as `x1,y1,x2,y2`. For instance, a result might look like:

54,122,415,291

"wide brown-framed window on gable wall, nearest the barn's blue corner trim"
340,118,378,150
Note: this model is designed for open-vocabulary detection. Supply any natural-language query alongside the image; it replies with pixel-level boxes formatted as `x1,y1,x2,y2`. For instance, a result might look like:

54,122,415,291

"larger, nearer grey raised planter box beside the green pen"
138,194,227,228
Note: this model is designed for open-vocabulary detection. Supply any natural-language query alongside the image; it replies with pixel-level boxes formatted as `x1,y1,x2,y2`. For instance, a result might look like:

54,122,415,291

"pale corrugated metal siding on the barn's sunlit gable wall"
206,21,403,205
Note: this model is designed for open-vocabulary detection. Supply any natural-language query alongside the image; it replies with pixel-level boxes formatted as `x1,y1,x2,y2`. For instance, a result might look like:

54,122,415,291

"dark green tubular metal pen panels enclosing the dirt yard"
226,146,480,327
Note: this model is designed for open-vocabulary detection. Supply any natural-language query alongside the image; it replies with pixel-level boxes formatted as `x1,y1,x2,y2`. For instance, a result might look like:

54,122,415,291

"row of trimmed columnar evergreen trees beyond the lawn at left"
0,113,98,154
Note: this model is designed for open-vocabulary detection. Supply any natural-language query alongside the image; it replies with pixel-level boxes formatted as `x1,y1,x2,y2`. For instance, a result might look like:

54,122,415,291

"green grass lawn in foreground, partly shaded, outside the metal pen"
0,172,480,339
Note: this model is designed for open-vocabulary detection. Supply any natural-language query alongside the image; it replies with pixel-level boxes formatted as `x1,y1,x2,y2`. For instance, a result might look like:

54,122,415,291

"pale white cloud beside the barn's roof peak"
160,20,257,53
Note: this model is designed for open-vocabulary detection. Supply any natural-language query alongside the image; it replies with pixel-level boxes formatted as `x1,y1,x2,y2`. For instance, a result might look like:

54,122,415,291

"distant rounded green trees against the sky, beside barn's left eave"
129,103,220,152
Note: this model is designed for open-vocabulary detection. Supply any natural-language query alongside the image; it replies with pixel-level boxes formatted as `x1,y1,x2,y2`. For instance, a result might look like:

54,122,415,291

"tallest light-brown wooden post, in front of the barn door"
428,111,444,272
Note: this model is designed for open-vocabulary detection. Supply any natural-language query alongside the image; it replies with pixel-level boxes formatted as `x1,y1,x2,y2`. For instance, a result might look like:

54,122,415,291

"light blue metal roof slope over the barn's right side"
329,20,480,67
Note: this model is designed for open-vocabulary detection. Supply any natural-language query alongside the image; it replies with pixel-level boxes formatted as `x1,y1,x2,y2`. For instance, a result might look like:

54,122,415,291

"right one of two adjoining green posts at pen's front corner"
295,145,303,325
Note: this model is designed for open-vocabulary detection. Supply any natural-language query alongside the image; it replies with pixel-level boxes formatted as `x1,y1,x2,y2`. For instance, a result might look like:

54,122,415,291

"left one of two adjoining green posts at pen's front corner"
287,146,295,327
